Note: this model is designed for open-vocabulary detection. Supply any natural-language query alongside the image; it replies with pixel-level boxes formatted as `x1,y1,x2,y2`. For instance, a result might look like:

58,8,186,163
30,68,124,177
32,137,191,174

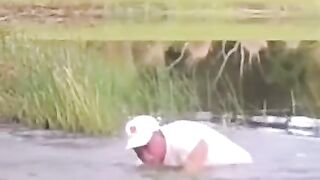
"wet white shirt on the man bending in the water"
161,120,252,166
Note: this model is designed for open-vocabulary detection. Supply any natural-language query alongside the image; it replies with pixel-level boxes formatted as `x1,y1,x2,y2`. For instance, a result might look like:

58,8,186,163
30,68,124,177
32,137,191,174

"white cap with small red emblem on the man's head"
126,115,160,149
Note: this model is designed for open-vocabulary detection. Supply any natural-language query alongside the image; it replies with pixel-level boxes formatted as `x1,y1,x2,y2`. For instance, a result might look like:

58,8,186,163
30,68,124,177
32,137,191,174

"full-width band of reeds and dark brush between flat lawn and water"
0,32,320,135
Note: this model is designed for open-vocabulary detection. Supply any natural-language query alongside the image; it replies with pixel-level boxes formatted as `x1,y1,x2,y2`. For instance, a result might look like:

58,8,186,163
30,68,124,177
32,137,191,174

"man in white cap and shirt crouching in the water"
125,115,252,172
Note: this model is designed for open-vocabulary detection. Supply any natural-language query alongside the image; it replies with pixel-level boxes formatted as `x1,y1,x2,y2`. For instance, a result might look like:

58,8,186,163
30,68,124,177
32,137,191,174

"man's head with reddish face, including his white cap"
126,115,166,165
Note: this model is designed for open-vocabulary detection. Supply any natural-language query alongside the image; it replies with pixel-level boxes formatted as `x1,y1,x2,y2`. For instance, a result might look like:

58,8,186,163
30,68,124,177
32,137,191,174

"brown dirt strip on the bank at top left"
0,5,109,25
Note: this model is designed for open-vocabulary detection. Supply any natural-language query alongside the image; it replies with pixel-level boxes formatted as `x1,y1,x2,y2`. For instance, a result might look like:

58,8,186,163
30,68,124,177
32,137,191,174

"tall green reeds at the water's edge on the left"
0,33,198,134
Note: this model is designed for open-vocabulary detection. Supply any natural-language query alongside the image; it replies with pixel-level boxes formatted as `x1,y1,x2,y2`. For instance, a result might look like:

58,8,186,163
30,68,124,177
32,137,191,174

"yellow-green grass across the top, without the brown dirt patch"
0,0,320,40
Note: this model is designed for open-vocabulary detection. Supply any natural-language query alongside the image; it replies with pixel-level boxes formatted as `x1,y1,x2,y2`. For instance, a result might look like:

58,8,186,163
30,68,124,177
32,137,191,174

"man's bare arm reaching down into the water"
183,140,208,173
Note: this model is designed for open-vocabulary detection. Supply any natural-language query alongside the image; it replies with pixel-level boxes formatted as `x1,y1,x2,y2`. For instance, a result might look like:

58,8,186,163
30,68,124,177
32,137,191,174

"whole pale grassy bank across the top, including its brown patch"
0,0,320,40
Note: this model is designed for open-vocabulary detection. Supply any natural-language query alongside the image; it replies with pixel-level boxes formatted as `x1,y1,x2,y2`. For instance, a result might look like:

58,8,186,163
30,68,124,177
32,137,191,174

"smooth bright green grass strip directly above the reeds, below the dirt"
6,20,320,41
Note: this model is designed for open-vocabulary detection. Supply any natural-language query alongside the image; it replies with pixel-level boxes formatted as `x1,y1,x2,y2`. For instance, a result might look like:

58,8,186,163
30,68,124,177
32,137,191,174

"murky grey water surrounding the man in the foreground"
0,125,320,180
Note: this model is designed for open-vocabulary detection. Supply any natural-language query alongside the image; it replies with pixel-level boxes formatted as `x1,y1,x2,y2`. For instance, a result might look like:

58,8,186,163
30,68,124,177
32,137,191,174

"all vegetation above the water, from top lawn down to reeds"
0,0,320,134
